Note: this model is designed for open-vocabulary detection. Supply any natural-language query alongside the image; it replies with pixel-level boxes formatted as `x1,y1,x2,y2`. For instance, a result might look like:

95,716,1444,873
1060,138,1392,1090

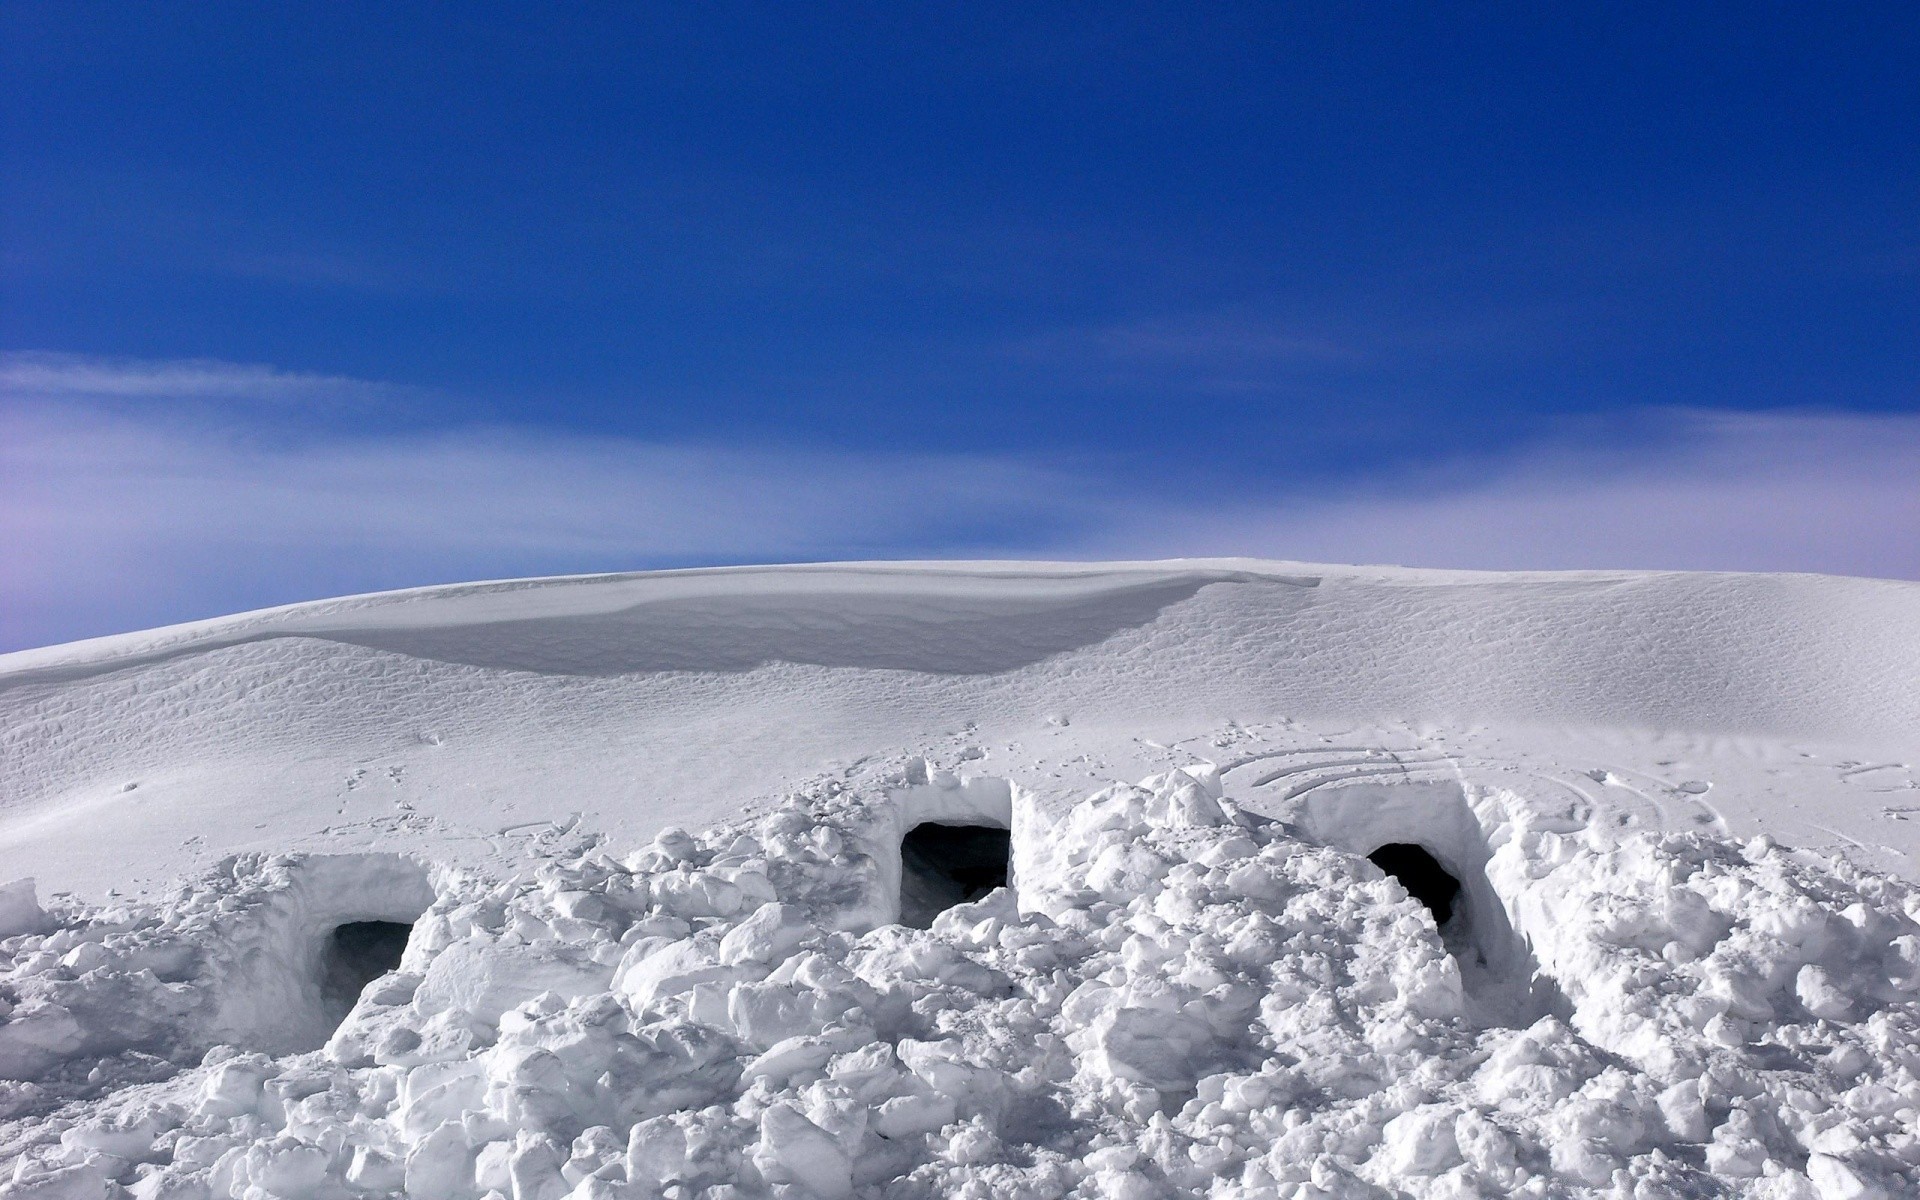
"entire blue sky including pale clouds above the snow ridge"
0,2,1920,649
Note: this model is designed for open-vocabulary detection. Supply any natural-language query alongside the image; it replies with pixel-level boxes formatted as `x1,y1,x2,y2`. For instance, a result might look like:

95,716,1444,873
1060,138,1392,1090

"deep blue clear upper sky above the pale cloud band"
0,0,1920,648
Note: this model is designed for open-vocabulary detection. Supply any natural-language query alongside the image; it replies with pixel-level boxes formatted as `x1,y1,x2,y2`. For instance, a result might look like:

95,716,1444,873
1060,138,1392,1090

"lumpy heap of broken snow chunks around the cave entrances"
0,772,1920,1200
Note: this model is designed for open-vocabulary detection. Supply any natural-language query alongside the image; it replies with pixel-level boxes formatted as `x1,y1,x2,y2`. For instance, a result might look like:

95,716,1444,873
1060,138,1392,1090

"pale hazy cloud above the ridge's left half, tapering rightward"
0,397,1102,649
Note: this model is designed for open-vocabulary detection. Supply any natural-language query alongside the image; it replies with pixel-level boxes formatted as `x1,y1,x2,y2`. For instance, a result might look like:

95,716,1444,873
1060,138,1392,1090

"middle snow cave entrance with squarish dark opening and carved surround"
877,776,1016,929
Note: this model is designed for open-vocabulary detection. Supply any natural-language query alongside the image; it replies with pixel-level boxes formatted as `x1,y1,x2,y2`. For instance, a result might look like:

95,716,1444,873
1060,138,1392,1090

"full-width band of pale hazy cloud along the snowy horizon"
0,355,1920,649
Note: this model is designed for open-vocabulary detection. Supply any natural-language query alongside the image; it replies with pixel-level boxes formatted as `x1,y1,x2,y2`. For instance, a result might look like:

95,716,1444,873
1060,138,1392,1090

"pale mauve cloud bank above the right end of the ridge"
1098,411,1920,578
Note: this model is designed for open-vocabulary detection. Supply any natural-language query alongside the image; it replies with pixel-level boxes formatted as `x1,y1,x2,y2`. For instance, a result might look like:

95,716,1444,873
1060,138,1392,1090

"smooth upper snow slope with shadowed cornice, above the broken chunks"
0,561,1920,895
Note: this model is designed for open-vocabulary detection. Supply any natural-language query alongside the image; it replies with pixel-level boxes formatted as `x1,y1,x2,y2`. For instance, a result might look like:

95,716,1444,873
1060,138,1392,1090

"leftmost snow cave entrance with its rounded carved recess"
215,854,436,1054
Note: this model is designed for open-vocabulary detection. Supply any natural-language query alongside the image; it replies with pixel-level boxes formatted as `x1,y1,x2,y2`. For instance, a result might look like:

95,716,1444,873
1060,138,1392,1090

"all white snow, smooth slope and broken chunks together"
0,561,1920,1200
